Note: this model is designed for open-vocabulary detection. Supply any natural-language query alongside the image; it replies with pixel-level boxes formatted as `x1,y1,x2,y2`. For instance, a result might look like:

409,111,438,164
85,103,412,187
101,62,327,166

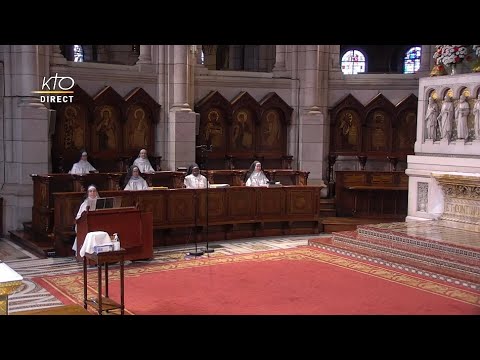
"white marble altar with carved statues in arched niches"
405,73,480,224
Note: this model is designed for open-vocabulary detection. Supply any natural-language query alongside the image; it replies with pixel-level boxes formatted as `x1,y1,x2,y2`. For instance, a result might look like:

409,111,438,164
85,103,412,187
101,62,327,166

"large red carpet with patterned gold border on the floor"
35,247,480,315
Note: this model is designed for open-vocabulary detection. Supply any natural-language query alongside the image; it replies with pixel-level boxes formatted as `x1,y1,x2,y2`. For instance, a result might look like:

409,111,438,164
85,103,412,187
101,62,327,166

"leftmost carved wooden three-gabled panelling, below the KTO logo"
52,85,160,172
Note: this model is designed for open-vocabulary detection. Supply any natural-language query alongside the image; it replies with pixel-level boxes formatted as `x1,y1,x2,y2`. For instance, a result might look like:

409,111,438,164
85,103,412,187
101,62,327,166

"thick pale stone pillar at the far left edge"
0,45,49,232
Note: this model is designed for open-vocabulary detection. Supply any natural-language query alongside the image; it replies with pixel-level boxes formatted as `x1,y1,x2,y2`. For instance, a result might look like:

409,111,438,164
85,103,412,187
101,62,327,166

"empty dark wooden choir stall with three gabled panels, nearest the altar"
327,94,418,220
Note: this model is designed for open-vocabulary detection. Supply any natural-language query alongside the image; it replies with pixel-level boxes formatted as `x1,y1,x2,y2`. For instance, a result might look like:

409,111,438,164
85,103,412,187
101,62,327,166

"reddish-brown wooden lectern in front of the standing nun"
77,207,153,261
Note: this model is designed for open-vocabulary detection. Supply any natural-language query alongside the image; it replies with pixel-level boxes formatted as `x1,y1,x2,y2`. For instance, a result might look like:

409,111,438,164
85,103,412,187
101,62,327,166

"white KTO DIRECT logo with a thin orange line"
32,73,75,103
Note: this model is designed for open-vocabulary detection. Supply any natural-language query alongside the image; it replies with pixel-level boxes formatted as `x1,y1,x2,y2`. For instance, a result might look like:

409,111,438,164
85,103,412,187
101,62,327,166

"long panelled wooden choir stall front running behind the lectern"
52,185,324,260
